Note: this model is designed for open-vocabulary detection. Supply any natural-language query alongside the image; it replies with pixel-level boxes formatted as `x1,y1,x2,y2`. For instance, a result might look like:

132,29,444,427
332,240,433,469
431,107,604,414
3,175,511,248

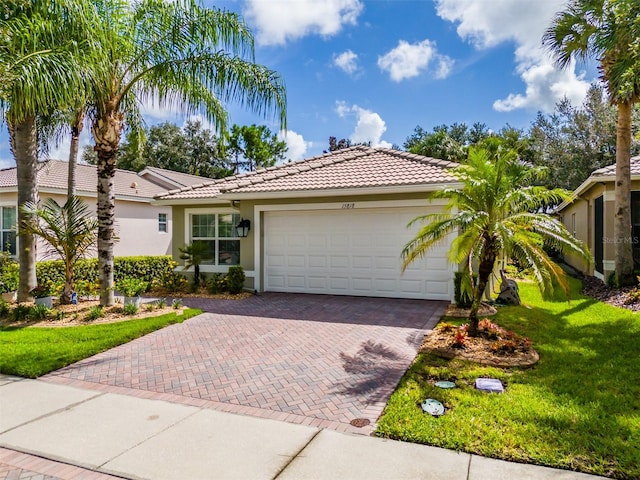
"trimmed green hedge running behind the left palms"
36,255,177,285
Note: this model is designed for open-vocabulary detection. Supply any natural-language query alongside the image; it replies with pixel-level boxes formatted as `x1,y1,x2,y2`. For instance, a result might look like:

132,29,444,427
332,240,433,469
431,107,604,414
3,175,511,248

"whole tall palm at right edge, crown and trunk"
542,0,640,286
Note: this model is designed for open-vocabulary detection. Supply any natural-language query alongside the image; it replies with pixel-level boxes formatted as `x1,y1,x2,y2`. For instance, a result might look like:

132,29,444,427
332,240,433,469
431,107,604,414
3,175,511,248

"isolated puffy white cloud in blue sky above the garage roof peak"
378,39,453,82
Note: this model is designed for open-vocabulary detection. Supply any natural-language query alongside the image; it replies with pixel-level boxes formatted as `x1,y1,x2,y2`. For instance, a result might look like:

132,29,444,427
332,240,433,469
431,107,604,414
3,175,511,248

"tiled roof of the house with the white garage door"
156,146,457,200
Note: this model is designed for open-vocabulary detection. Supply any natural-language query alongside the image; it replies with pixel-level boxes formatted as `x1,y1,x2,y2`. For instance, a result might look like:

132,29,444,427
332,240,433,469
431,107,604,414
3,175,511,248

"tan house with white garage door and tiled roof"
153,146,455,300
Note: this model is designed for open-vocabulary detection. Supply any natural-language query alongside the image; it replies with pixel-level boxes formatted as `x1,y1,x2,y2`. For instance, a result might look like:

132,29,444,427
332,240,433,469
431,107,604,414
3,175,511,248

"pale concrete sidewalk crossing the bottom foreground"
0,375,598,480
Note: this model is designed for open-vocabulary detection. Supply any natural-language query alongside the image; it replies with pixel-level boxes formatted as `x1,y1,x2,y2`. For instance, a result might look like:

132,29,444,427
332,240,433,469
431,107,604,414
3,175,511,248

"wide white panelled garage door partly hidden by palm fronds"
264,207,453,300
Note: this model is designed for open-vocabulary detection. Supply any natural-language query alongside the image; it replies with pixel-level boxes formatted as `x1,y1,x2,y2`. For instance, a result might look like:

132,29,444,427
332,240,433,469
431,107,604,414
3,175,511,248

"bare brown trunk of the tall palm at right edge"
614,101,636,286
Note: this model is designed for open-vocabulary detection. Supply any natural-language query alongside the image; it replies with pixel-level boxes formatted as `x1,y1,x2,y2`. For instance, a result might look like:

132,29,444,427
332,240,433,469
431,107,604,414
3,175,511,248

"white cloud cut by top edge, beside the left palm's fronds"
243,0,363,45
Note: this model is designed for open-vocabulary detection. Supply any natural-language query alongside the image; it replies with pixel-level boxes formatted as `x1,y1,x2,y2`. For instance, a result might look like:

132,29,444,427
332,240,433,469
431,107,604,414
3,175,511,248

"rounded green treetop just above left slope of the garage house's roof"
225,125,288,173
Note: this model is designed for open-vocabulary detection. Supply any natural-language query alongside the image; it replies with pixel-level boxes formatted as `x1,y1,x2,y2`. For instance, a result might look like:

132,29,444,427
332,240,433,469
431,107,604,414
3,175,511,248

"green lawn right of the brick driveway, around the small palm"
377,281,640,479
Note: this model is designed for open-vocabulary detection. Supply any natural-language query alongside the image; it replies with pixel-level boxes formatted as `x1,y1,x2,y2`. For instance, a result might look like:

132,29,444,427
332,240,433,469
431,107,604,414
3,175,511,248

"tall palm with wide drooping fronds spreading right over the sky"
82,0,286,306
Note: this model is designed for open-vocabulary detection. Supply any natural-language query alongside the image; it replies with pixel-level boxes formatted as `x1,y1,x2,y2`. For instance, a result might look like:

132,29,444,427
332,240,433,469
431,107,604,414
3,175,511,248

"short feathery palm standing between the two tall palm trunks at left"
21,195,98,303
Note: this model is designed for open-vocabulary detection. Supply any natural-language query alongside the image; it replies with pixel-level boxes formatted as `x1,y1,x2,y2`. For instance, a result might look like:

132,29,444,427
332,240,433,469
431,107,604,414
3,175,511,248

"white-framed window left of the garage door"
189,213,240,265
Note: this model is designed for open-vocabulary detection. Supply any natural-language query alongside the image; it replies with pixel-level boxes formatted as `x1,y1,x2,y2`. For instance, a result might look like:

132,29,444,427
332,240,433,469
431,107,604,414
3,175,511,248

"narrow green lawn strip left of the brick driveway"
0,309,201,378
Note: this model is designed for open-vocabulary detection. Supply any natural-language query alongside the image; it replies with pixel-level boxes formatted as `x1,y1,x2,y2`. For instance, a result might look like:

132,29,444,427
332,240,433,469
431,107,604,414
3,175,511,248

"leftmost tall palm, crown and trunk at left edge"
0,0,92,301
